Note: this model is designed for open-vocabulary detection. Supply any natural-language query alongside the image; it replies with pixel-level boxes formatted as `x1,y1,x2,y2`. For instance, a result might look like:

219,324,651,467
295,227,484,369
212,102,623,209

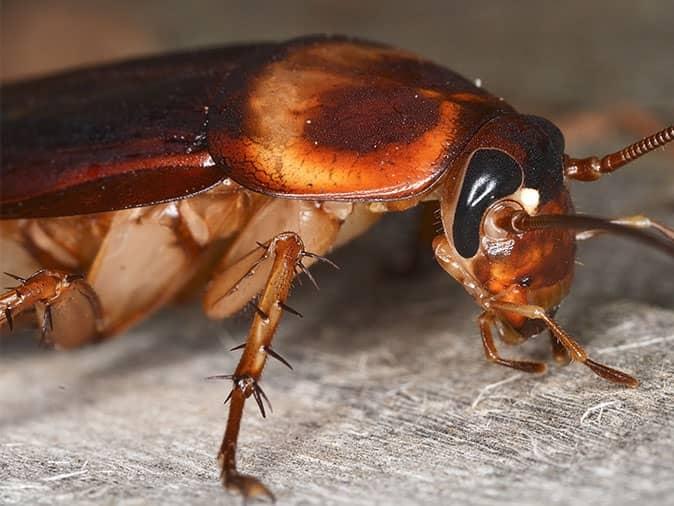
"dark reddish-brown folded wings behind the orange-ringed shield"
0,45,265,218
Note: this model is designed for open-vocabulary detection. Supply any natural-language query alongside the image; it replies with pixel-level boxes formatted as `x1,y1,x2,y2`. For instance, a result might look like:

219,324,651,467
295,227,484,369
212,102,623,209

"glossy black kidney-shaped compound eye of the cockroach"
452,149,522,258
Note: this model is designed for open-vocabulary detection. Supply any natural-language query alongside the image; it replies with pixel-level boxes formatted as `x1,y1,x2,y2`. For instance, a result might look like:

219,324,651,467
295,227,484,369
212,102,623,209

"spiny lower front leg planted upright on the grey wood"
218,232,306,501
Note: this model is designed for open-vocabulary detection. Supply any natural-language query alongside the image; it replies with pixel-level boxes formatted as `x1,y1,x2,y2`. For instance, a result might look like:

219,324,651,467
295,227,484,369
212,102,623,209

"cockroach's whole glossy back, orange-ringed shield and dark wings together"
0,37,510,218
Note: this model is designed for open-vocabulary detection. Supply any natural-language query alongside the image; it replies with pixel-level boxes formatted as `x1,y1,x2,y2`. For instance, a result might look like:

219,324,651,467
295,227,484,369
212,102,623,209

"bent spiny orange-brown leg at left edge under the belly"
0,269,102,347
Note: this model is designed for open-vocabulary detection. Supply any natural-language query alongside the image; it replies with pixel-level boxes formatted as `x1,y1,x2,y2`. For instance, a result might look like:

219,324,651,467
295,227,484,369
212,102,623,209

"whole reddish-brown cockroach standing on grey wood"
0,36,674,498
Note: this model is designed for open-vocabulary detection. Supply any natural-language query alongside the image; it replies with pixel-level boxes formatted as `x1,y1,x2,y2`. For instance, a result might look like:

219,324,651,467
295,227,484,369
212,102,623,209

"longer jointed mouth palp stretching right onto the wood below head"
487,301,639,388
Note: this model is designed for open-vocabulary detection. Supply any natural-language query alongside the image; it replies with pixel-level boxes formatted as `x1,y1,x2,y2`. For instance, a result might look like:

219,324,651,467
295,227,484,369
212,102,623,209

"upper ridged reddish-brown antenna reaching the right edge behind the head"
564,125,674,181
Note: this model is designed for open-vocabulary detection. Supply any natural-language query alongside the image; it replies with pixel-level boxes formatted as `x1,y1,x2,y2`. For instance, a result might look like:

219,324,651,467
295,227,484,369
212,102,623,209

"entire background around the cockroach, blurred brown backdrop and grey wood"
0,0,674,505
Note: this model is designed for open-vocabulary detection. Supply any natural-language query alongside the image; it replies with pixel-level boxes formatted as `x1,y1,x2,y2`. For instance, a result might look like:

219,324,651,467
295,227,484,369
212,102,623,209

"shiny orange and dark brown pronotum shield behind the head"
208,37,512,200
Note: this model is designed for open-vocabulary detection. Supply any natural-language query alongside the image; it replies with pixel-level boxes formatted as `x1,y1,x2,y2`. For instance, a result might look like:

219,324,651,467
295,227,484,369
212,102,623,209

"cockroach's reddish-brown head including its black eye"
441,114,575,333
